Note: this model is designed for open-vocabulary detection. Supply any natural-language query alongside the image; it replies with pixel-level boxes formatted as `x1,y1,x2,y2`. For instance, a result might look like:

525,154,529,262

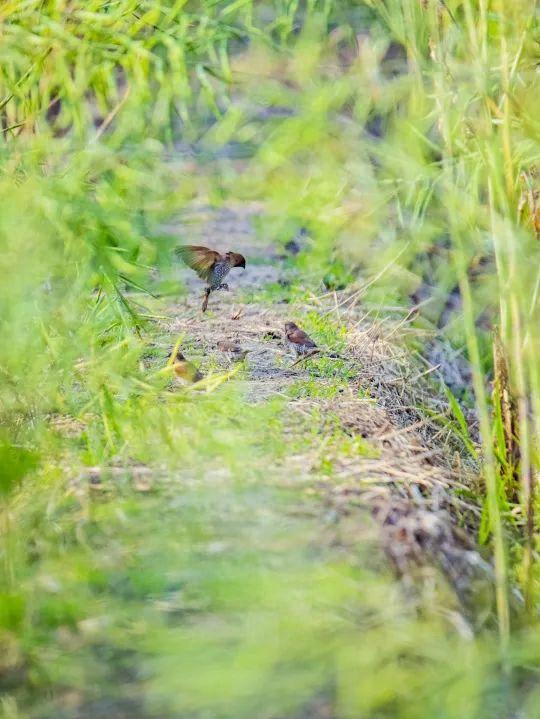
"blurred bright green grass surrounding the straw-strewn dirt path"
0,0,540,719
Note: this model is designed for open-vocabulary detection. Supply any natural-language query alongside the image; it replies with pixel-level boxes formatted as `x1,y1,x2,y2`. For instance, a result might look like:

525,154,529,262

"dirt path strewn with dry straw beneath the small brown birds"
167,204,491,624
